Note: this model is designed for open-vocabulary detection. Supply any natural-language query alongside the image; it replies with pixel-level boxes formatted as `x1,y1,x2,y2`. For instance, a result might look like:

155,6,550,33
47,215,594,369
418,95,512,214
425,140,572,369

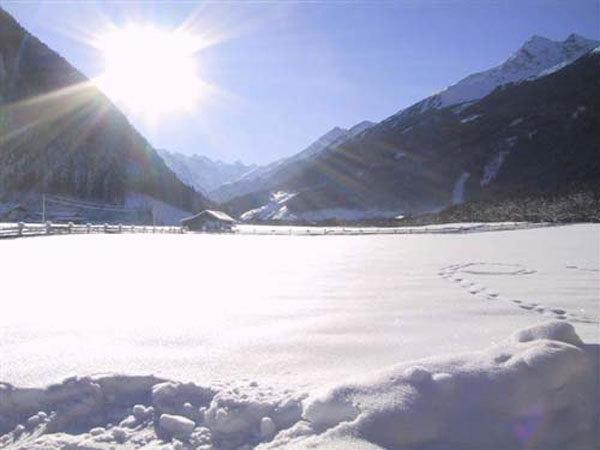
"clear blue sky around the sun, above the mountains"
0,0,600,163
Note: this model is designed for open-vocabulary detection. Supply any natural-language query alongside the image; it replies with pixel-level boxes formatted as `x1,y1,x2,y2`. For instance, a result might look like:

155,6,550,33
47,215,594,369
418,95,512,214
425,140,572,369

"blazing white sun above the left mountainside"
95,25,203,120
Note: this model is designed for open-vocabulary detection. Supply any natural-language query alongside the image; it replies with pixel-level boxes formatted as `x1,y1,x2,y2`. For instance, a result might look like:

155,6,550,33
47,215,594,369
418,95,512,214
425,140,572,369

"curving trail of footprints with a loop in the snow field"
438,262,598,323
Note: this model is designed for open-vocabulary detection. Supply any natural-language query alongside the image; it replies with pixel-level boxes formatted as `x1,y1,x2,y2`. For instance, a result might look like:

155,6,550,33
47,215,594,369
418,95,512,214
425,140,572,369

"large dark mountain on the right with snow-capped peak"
227,36,600,221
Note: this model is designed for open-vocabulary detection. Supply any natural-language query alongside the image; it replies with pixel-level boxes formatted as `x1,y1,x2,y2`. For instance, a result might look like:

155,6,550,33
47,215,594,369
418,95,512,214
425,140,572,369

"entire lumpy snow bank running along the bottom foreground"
0,322,600,450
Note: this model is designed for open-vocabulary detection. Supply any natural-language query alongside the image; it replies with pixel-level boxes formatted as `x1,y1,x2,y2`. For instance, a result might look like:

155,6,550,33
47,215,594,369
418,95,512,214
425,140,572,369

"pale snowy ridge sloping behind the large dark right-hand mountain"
210,120,375,202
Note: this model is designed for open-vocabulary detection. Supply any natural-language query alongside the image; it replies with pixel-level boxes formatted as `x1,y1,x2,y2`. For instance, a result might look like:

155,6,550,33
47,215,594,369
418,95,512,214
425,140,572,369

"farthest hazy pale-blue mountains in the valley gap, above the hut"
158,150,258,195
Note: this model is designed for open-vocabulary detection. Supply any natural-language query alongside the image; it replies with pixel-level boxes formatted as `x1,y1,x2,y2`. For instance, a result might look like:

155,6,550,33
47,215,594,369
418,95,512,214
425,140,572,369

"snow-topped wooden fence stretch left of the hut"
0,222,186,238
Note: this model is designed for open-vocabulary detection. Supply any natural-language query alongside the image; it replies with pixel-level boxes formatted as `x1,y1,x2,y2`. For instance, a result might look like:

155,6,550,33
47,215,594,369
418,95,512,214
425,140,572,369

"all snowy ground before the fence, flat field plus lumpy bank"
0,225,600,449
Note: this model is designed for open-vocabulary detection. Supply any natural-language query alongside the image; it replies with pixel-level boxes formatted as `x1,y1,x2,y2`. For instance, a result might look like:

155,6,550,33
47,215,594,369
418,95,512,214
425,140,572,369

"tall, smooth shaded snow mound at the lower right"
261,322,599,450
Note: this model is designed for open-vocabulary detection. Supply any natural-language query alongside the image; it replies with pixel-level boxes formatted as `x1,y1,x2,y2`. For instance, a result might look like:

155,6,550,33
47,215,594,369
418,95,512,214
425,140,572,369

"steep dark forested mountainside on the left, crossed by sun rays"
0,9,209,222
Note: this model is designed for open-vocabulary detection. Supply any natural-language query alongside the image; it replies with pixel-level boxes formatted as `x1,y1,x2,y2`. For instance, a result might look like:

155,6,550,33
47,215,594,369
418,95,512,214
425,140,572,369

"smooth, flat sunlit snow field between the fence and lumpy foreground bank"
0,225,600,389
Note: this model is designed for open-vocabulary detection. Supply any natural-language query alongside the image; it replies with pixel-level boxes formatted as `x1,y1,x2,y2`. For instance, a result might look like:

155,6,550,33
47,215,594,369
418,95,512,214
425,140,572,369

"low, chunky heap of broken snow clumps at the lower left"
0,375,306,450
